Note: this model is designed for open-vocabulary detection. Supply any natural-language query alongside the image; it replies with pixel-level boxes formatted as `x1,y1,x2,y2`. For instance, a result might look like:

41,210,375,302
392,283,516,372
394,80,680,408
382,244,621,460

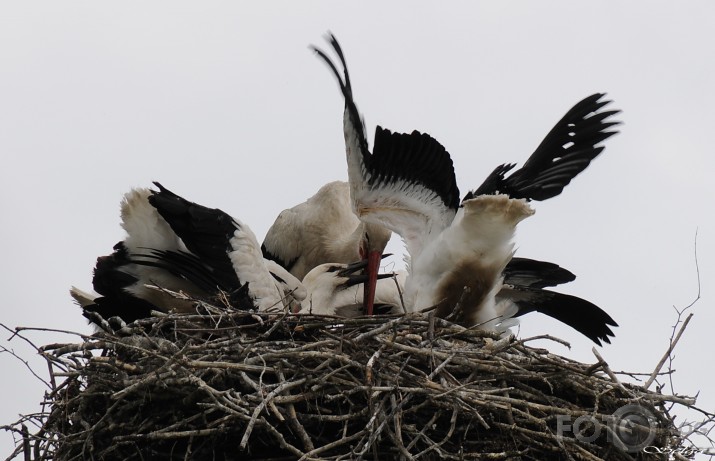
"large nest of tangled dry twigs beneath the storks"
1,302,704,460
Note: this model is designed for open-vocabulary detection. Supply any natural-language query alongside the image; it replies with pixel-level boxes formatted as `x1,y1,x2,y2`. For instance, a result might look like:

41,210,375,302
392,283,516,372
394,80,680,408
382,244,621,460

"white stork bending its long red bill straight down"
261,181,392,315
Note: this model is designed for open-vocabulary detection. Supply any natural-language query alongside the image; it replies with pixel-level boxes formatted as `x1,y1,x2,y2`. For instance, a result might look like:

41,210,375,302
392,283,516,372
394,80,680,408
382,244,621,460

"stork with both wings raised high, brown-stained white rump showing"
314,35,618,342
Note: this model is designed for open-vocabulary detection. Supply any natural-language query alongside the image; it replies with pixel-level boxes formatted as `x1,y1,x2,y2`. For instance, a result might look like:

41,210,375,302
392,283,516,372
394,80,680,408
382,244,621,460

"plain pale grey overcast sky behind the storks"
0,0,715,458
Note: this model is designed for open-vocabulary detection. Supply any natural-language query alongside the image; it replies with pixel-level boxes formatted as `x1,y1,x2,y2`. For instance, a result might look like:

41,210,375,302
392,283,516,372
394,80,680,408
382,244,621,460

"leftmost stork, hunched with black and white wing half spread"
71,183,306,322
